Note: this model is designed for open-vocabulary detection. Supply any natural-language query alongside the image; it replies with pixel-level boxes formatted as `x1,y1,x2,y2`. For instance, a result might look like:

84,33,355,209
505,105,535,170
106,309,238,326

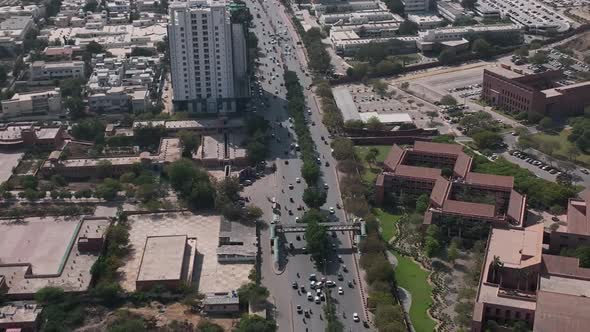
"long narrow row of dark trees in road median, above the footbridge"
284,71,321,187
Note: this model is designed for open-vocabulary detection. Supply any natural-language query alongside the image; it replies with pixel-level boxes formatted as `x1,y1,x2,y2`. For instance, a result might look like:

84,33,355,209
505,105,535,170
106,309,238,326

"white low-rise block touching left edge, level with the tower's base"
0,88,63,119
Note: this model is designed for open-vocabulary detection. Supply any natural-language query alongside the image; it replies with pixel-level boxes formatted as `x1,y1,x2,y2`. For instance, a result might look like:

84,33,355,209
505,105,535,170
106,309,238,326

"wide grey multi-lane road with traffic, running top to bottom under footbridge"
239,0,368,332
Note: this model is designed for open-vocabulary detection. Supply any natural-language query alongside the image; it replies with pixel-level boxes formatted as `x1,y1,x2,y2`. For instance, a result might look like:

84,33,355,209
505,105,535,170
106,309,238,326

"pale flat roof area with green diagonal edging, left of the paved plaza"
0,217,110,298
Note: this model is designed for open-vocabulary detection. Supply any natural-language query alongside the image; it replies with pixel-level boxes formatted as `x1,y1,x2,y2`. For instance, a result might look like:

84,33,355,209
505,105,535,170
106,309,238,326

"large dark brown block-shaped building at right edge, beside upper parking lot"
481,65,590,117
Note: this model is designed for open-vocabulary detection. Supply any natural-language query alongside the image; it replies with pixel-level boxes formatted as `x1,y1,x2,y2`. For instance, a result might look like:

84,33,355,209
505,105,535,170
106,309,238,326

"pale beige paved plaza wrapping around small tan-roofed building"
121,212,254,293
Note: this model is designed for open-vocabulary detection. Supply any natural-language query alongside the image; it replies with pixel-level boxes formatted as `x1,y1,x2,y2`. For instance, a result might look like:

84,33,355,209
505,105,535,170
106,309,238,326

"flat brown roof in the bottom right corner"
533,291,590,332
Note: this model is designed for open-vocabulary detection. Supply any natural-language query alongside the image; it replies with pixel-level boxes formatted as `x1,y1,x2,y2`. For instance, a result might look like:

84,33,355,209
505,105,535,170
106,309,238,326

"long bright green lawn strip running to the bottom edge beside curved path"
394,252,436,332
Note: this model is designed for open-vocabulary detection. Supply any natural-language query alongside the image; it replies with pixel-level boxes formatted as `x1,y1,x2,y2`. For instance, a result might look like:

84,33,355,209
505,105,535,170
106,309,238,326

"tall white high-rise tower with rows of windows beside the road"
168,0,249,113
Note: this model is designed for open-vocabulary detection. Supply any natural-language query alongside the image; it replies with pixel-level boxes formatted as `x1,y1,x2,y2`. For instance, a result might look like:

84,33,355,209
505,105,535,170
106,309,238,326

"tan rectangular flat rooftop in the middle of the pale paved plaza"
137,235,187,281
